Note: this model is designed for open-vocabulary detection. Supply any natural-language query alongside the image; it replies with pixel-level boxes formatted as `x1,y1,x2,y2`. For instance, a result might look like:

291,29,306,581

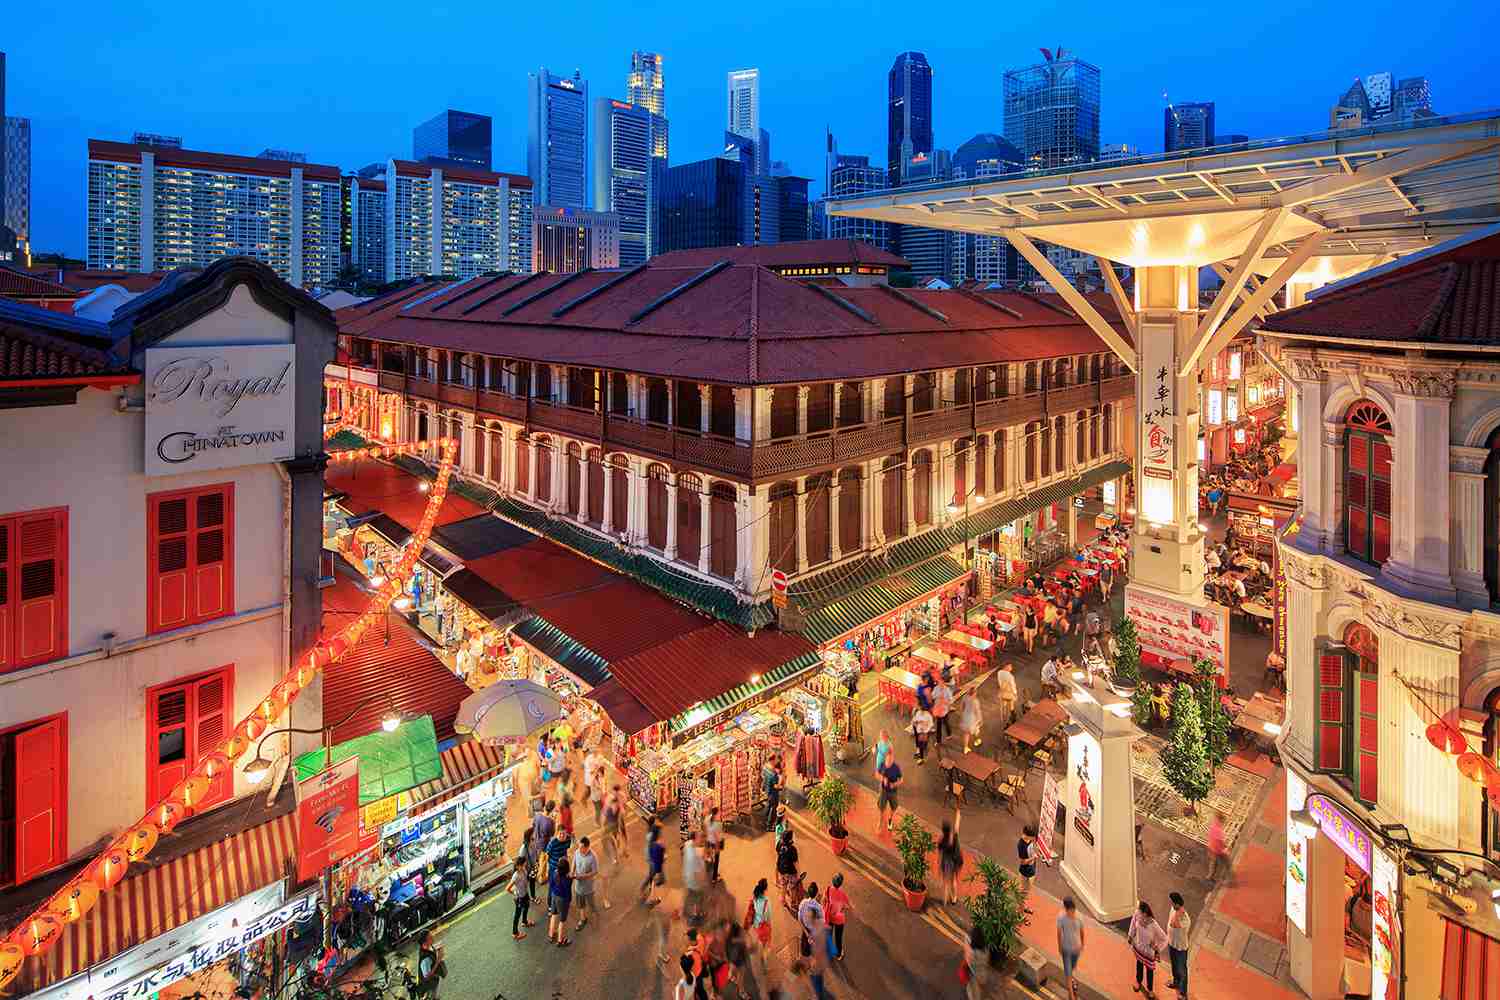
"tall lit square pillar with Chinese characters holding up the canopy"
1130,265,1205,604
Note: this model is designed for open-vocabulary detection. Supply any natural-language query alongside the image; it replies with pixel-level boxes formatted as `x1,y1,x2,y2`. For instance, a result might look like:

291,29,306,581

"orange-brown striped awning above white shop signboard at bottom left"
12,807,297,996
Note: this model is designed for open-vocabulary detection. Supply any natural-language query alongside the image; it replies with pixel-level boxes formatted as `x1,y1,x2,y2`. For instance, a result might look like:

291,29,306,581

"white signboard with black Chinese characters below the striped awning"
32,880,304,1000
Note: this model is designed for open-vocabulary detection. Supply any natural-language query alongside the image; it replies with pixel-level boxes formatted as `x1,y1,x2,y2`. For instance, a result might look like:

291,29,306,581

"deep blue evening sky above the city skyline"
11,0,1500,256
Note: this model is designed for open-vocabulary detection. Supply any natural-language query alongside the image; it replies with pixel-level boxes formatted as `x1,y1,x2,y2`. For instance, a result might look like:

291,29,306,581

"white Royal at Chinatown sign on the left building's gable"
146,343,296,475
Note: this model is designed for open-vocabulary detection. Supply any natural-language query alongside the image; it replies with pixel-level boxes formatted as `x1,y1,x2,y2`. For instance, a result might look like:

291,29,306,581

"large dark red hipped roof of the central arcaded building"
339,263,1128,385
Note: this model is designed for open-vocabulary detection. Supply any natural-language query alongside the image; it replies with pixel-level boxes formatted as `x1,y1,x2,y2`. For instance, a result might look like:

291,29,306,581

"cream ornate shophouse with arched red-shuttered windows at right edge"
1262,229,1500,1000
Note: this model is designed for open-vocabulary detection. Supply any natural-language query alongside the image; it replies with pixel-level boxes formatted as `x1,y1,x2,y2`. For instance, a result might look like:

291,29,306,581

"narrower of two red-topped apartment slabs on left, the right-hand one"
386,160,533,282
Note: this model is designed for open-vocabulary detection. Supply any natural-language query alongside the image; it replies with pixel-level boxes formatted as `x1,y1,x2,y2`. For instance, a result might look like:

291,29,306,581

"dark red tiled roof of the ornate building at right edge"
1262,235,1500,346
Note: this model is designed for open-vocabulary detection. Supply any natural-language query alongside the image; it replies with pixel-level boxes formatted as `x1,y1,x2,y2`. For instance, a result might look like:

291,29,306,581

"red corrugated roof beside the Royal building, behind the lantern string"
323,576,471,742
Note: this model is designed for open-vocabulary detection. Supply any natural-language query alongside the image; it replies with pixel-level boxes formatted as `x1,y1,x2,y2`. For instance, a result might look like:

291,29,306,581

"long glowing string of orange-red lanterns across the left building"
0,434,458,988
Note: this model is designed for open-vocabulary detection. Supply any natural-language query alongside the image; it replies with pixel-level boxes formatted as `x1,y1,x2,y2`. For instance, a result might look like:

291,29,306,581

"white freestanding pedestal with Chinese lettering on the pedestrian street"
1059,685,1140,921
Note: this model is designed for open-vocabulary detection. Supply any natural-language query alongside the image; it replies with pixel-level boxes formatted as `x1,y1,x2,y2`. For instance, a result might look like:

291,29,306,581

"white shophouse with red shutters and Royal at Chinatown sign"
0,258,335,997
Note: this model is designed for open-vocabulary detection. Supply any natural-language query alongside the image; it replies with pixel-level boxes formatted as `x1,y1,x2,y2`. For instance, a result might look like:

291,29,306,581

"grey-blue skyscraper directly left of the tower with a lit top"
591,98,666,267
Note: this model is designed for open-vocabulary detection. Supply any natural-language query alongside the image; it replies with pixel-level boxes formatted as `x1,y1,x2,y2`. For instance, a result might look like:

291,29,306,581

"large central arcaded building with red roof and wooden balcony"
329,241,1134,624
